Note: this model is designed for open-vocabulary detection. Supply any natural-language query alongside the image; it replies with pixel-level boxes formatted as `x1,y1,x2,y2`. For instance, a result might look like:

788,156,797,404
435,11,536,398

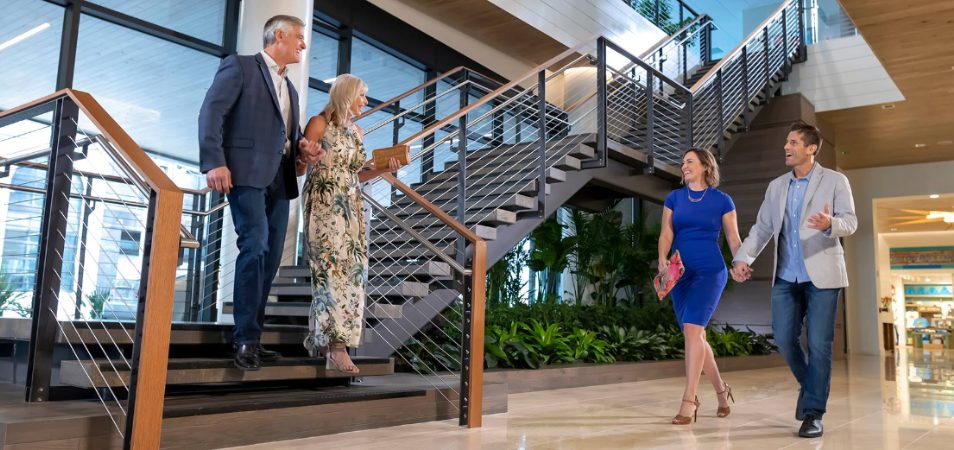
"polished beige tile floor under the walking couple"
225,351,954,450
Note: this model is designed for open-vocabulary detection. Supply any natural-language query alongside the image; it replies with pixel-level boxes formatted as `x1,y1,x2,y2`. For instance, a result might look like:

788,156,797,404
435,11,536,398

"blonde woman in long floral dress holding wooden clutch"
304,74,398,374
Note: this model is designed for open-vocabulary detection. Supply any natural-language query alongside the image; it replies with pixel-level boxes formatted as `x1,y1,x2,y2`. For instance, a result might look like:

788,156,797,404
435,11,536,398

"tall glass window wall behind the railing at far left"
0,0,232,320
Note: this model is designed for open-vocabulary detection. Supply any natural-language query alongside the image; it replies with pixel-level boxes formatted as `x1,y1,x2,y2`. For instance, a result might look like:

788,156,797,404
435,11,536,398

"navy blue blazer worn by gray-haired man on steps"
199,53,302,198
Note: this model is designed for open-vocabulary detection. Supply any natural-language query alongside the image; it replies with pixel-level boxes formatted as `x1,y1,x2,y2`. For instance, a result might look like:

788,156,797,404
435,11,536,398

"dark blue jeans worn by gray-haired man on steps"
228,163,288,344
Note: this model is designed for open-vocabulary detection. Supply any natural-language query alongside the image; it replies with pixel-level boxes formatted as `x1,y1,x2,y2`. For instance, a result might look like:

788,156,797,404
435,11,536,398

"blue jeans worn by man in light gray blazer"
772,278,841,420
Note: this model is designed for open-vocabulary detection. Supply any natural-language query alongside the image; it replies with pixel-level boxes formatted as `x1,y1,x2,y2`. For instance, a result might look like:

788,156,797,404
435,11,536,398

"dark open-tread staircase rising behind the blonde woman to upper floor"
253,2,798,357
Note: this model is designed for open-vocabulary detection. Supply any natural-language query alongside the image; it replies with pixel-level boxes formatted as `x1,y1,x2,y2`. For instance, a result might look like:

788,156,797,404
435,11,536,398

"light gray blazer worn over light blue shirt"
733,163,858,289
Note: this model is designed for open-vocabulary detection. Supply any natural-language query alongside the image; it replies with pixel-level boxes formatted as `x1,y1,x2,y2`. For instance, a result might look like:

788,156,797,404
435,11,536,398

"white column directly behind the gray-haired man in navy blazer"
218,0,312,321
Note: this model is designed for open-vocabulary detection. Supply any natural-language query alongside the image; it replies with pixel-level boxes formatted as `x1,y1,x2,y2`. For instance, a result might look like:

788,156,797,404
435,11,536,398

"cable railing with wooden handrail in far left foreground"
0,90,182,448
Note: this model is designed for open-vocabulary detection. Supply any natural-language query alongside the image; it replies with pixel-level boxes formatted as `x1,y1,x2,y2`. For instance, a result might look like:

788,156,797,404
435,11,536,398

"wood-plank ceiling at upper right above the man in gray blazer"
819,0,954,169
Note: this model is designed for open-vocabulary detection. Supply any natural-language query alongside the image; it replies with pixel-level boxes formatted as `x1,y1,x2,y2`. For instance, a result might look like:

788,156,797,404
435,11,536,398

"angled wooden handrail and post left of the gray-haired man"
0,89,183,448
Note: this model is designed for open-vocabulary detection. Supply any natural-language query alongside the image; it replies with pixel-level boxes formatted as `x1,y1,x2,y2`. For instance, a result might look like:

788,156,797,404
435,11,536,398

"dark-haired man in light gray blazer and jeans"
732,122,858,438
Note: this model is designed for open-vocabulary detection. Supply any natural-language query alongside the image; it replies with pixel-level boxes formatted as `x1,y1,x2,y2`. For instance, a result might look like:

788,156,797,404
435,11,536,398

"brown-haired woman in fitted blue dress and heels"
659,148,742,425
